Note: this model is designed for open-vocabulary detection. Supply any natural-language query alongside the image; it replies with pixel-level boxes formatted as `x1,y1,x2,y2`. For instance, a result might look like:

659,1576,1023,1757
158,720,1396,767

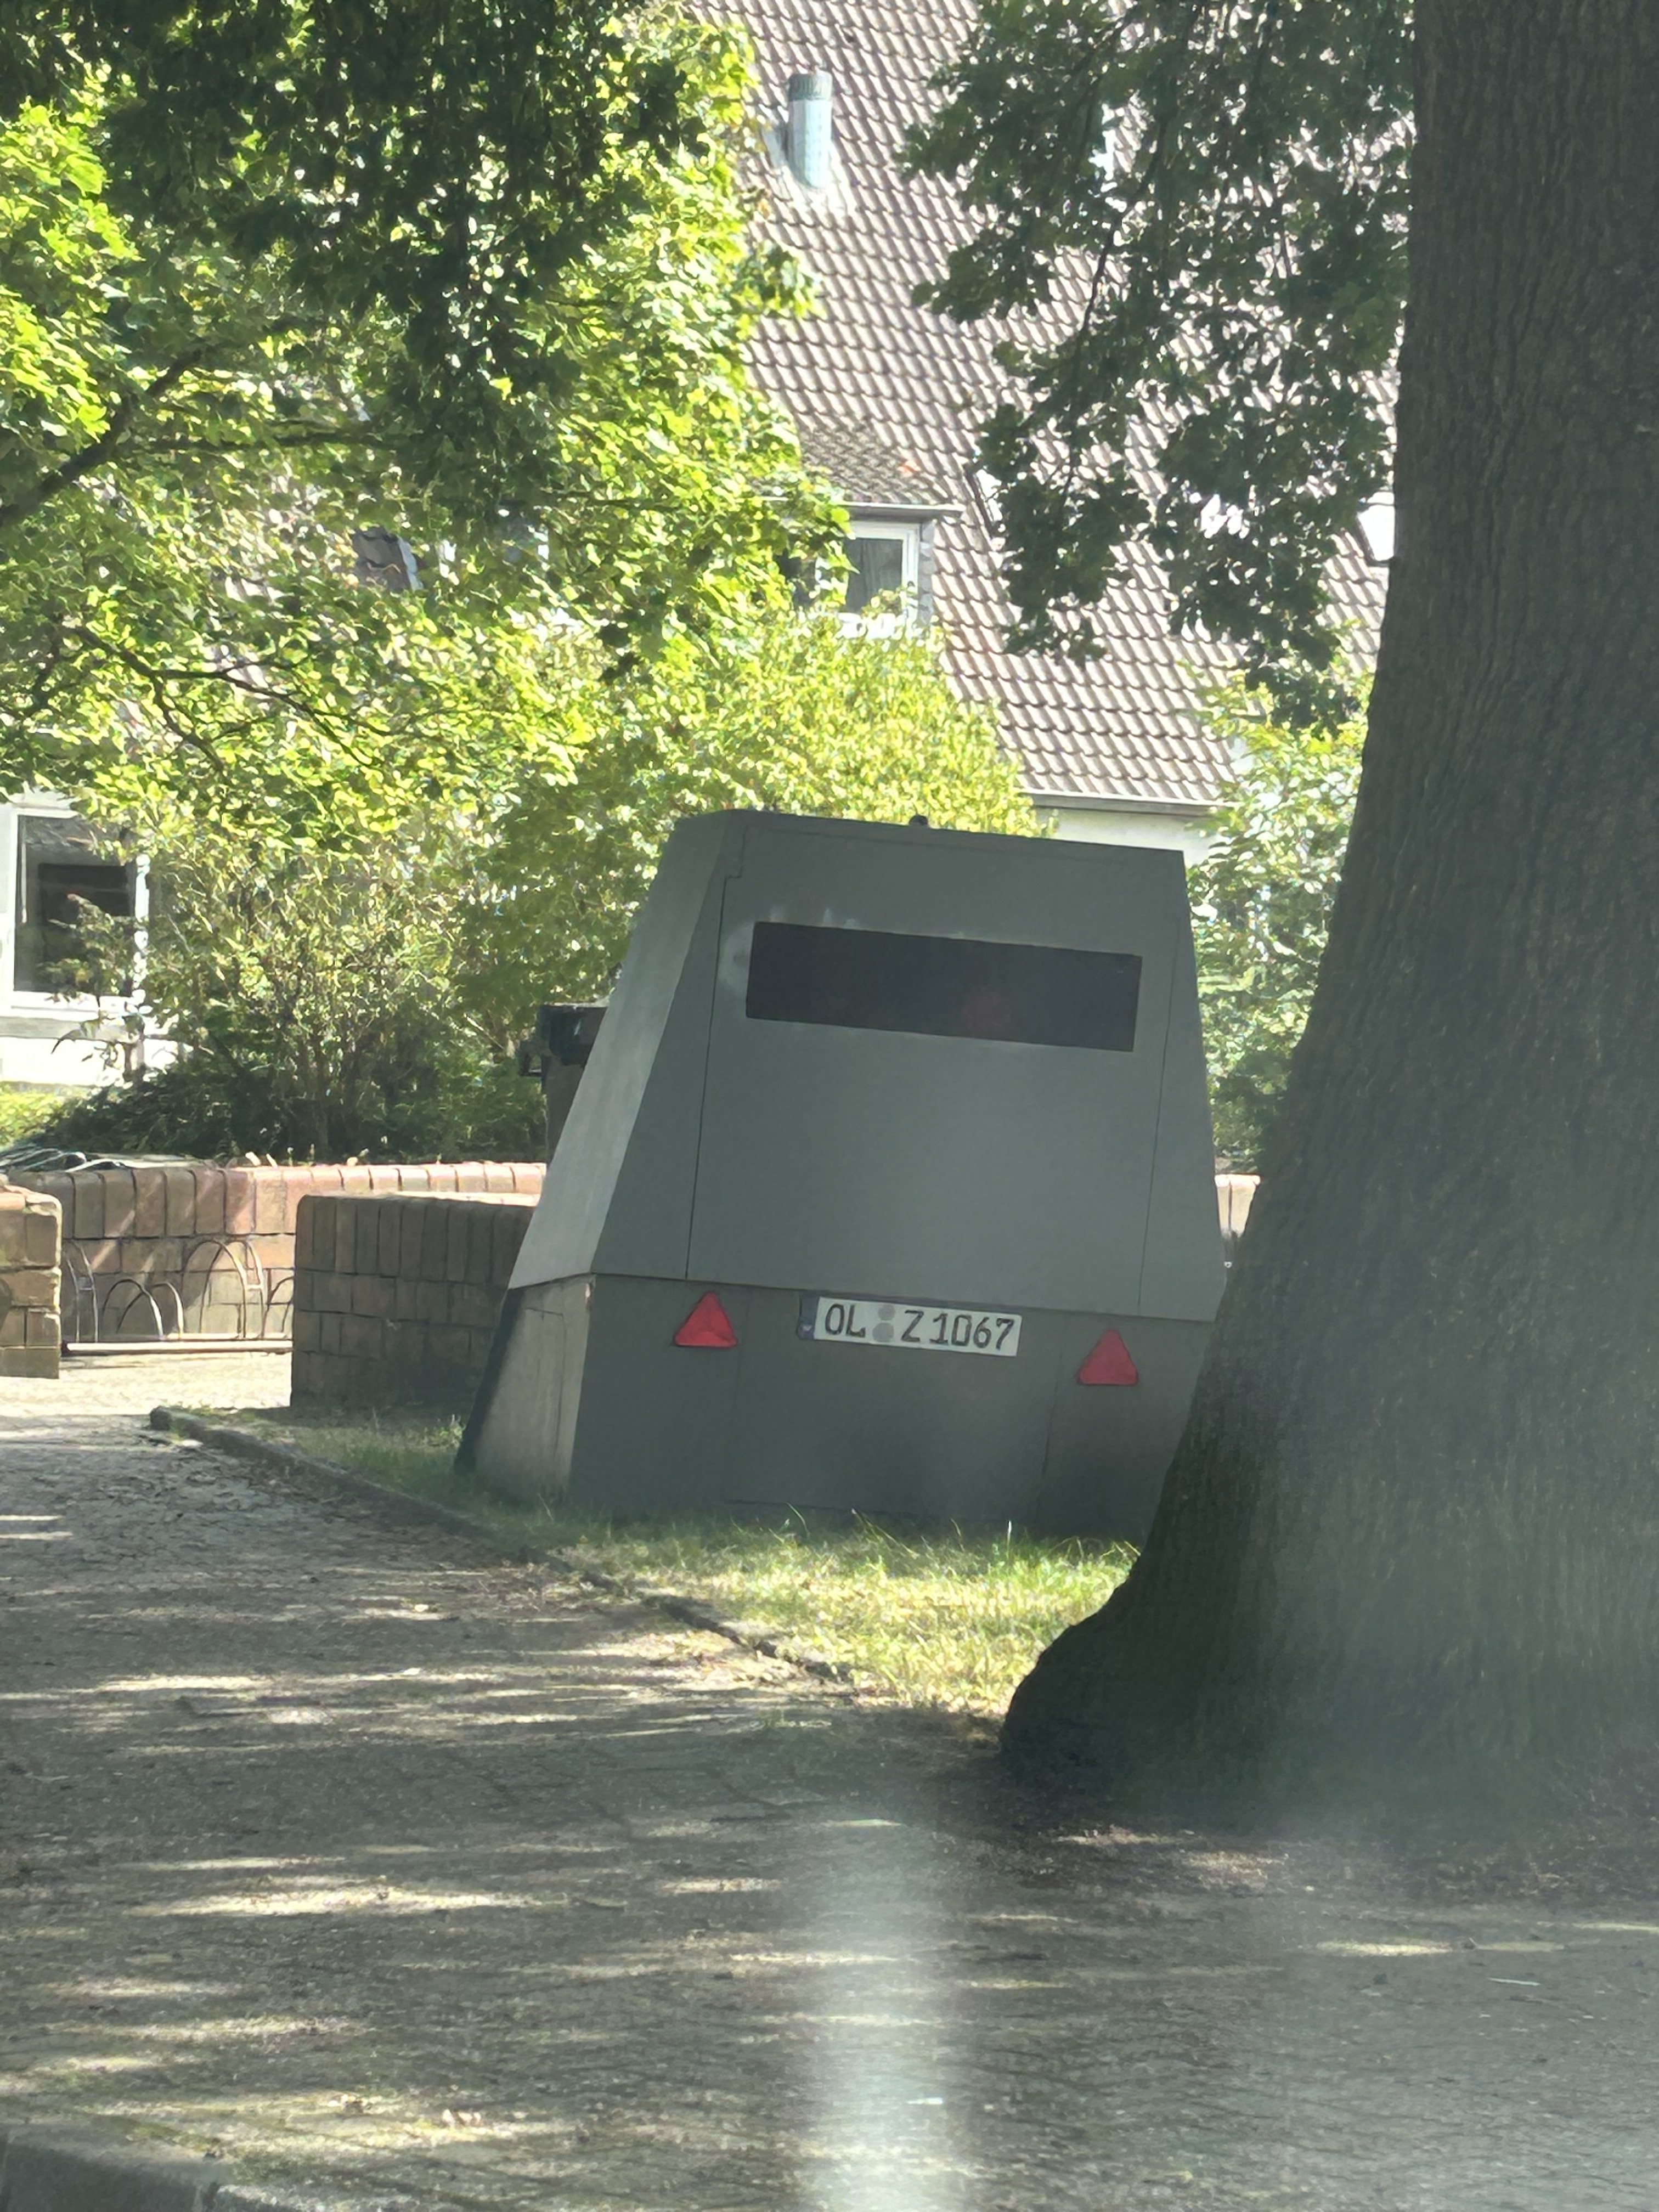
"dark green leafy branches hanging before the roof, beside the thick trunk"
909,0,1411,679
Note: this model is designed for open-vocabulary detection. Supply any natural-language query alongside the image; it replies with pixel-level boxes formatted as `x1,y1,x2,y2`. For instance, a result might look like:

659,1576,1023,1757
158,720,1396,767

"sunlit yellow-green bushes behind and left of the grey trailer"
55,608,1035,1159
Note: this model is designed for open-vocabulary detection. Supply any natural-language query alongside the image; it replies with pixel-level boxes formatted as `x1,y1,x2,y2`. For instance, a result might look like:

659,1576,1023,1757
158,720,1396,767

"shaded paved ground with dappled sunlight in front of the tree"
0,1358,1659,2212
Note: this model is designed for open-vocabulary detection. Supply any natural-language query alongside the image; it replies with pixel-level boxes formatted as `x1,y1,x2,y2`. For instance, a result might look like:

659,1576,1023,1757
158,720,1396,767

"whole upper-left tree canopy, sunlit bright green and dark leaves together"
0,4,834,825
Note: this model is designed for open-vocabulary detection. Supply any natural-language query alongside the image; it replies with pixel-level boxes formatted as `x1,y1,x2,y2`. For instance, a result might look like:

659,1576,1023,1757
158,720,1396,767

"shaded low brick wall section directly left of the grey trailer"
292,1192,535,1411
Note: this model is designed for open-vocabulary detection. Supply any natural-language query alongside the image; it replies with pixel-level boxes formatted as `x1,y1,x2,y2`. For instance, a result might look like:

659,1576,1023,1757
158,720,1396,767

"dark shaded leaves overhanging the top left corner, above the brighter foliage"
0,0,818,544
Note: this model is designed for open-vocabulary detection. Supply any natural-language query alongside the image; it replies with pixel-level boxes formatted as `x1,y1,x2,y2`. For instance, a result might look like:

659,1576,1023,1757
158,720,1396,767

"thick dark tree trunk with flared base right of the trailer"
1005,0,1659,1801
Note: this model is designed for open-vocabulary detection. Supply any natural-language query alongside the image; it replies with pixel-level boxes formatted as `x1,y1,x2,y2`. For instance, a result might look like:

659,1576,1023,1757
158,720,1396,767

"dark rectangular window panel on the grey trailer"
743,922,1142,1053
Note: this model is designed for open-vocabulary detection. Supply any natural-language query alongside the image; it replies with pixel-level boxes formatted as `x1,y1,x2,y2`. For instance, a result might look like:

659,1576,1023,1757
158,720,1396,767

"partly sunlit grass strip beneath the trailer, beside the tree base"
208,1409,1135,1714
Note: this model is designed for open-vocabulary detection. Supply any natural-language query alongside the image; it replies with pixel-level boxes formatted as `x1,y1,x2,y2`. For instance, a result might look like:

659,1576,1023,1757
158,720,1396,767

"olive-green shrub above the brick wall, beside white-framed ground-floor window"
41,825,542,1159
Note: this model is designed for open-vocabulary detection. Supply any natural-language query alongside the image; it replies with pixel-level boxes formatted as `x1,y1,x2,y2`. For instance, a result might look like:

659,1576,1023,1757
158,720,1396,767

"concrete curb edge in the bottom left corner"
0,2124,347,2212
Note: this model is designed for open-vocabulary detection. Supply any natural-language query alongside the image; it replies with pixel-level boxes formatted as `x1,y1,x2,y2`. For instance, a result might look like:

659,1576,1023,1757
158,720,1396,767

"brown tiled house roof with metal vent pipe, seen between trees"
716,0,1385,851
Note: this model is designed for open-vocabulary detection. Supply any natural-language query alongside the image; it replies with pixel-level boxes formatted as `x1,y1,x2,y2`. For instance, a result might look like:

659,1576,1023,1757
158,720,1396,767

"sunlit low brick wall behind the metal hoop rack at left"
15,1161,542,1340
